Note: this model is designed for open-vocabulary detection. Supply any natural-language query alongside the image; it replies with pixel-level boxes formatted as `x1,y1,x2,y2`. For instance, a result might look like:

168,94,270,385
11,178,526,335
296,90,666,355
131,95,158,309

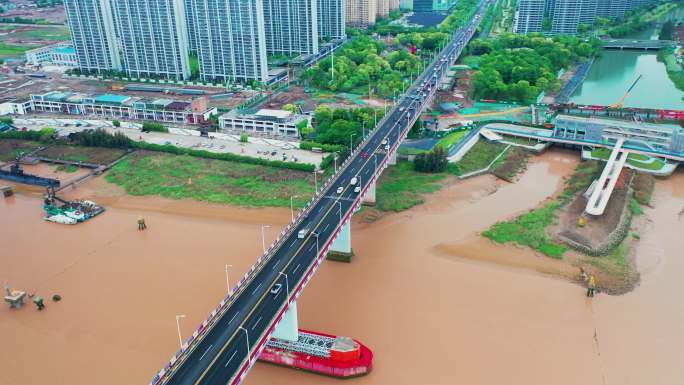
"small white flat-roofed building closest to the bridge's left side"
219,109,309,138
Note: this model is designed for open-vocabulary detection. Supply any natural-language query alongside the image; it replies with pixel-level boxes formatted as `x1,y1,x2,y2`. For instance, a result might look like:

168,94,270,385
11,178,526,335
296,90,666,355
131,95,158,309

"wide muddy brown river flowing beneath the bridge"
0,151,684,385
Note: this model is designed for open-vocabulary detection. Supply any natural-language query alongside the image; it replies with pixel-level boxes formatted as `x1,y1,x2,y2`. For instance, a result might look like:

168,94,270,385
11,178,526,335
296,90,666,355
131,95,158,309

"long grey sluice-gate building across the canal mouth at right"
553,115,684,156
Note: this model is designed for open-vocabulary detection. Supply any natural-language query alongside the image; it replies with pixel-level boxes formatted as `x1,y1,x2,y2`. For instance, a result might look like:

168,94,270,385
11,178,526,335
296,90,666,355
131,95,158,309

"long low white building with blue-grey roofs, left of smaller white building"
4,91,217,125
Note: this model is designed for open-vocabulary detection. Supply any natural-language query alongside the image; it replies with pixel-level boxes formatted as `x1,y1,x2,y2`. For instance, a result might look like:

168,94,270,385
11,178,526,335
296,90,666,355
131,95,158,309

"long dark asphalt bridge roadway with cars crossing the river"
152,0,491,385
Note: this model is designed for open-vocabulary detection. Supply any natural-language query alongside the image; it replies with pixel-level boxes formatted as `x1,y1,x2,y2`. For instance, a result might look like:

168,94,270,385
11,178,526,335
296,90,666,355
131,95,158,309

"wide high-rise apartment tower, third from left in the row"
191,0,268,82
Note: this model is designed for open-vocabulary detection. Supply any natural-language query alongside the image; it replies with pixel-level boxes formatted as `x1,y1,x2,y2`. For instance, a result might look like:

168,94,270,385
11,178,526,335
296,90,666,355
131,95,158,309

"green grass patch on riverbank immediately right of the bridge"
376,162,446,212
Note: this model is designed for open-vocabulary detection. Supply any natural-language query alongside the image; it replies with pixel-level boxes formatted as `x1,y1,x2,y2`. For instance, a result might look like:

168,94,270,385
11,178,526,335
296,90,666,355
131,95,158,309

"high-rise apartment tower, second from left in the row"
111,0,190,80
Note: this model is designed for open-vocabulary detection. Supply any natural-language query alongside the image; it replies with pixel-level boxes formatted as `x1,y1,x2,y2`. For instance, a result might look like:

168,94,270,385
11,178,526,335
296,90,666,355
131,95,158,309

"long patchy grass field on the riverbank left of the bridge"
106,153,314,207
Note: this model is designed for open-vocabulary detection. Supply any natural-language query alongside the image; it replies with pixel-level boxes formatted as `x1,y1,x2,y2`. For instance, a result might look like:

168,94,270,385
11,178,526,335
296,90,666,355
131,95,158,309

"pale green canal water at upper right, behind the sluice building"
571,7,684,110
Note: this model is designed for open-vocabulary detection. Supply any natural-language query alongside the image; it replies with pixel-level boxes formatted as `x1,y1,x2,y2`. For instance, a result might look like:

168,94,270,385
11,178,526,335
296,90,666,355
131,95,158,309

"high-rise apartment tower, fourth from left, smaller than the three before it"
261,0,318,55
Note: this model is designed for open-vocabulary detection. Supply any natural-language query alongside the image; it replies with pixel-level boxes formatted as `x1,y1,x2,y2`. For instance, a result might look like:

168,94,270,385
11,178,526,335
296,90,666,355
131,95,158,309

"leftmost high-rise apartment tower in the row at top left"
64,0,121,73
